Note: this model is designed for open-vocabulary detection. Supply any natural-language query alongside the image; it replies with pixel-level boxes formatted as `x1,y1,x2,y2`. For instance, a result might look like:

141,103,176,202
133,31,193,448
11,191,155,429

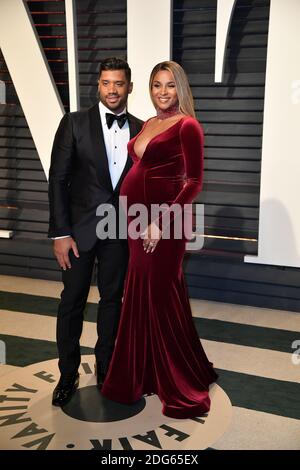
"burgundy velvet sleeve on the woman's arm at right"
155,117,204,228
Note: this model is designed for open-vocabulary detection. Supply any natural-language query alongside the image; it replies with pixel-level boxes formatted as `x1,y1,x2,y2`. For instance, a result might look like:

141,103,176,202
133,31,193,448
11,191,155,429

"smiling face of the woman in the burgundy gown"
151,70,178,111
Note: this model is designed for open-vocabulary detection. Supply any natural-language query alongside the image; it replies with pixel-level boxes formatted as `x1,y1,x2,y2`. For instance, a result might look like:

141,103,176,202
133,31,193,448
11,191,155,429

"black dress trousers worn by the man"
57,239,128,377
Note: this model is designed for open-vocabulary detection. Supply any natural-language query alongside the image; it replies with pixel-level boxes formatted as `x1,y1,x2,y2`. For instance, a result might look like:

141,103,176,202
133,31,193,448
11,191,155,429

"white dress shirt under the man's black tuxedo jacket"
52,101,130,240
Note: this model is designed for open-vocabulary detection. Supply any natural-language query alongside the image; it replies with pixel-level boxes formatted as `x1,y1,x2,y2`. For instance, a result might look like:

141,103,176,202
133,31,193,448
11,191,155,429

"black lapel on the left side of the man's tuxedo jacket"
89,104,113,193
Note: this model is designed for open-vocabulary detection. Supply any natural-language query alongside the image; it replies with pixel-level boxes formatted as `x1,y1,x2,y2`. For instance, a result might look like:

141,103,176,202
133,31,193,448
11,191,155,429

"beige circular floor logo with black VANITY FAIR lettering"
0,356,232,450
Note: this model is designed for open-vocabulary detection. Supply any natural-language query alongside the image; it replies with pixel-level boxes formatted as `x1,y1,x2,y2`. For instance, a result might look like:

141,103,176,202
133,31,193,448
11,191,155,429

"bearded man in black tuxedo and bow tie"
49,58,142,406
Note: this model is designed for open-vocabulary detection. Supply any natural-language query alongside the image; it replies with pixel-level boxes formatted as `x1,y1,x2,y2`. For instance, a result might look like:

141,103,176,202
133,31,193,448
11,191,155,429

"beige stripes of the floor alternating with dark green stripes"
0,276,300,450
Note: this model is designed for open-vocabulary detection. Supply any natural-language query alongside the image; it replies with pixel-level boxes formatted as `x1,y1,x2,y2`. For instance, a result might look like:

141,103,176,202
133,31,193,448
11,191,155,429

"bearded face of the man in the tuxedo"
98,70,132,114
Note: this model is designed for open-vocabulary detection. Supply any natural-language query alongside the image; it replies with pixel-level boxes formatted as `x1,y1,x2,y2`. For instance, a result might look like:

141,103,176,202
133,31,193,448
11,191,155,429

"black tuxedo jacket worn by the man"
48,103,143,251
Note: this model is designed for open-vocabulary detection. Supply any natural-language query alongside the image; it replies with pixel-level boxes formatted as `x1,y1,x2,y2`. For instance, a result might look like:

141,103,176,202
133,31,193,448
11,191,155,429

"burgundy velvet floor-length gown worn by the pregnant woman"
102,116,217,418
